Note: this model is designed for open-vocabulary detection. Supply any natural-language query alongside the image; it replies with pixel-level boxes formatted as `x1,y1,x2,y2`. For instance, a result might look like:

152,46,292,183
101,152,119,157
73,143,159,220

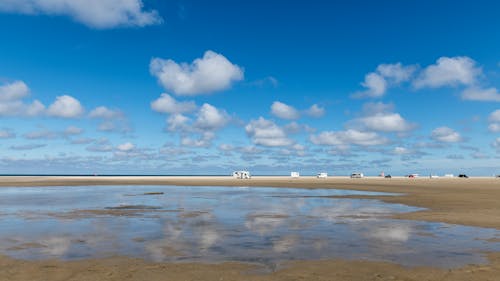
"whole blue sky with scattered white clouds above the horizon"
0,0,500,175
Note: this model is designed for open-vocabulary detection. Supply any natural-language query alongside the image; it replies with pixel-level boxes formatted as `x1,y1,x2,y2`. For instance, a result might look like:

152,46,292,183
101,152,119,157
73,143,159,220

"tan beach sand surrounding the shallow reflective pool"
0,177,500,281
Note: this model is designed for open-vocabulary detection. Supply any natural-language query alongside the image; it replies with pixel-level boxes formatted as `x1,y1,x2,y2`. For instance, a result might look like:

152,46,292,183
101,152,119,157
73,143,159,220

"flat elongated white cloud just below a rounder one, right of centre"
310,129,389,147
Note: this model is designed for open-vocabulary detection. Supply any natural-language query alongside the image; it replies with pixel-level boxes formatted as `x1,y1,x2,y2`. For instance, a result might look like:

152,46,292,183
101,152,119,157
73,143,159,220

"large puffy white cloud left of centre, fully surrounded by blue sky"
149,51,243,96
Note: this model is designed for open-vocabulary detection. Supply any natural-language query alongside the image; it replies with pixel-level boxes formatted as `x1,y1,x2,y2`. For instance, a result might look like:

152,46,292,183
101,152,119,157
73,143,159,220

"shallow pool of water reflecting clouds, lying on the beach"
0,186,500,267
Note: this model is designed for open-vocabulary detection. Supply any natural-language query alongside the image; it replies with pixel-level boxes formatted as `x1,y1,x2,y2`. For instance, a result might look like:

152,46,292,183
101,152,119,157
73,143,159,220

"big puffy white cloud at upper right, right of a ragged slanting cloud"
413,57,482,88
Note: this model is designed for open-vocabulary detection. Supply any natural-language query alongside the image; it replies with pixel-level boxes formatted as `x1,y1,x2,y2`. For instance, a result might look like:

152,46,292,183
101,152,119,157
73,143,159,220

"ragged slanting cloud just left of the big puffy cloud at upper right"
353,62,416,98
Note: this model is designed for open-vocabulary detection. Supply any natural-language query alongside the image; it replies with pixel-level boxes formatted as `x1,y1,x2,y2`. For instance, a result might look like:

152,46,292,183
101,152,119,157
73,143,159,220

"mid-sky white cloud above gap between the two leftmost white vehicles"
245,117,293,146
